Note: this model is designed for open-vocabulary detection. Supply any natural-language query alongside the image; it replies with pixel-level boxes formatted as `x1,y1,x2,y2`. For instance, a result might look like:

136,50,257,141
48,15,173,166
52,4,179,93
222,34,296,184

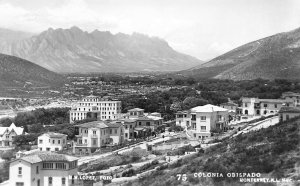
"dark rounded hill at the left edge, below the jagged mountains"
0,54,63,88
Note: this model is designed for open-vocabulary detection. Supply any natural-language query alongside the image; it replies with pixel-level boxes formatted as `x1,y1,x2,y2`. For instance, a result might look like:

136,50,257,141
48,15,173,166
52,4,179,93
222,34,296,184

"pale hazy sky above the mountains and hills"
0,0,300,60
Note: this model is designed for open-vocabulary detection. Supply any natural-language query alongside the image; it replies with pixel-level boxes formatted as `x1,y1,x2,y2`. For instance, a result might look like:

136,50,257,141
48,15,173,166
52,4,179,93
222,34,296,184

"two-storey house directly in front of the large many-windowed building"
73,121,124,153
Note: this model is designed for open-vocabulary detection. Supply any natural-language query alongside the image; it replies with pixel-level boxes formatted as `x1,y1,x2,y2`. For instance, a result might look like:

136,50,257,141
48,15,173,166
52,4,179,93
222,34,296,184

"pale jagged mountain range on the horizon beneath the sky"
0,27,202,73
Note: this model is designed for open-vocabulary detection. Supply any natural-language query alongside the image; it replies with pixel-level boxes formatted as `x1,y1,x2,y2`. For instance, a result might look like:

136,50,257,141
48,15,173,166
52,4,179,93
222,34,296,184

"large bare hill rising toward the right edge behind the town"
180,28,300,80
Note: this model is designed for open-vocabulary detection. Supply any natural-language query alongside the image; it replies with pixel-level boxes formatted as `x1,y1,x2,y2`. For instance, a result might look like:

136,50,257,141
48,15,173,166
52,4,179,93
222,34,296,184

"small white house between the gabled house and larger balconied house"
38,132,67,151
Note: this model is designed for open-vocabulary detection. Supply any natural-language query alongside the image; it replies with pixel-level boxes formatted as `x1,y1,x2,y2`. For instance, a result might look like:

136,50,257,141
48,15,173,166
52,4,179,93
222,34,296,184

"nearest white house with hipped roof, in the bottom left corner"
9,152,82,186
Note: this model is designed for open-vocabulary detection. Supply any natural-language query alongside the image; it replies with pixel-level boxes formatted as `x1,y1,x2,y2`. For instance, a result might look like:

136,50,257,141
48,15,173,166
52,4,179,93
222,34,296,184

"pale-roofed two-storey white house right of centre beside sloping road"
176,104,229,139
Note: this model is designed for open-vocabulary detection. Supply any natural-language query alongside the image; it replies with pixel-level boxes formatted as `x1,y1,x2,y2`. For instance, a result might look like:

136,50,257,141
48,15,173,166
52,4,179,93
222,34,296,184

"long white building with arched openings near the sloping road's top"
242,98,293,116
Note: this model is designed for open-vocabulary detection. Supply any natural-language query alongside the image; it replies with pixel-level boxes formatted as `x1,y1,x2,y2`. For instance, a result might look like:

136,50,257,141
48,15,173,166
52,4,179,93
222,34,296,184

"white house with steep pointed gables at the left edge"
0,123,24,147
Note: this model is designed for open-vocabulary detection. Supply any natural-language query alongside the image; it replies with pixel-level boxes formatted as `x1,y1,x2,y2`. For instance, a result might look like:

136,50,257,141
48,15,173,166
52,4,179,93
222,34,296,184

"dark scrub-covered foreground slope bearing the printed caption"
124,117,300,186
